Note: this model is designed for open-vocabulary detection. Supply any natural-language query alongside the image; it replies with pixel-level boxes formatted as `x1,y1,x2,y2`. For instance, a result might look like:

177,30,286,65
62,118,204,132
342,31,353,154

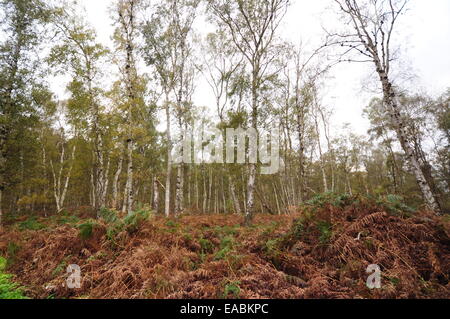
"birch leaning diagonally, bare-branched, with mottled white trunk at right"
327,0,441,214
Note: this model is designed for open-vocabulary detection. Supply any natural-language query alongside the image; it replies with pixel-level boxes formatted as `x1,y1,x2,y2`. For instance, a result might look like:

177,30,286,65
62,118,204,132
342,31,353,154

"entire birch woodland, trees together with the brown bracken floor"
0,0,450,299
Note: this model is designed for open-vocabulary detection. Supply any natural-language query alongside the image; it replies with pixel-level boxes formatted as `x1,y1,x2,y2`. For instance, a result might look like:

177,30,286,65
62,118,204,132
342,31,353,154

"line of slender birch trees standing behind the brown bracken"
0,0,450,230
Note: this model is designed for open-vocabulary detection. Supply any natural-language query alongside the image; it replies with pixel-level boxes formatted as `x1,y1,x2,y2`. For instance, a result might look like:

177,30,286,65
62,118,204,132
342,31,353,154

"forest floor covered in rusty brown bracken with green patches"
0,196,450,299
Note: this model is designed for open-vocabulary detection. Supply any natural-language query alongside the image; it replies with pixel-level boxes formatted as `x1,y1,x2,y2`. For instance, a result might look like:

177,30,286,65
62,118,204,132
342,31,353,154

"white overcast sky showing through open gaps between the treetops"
80,0,450,134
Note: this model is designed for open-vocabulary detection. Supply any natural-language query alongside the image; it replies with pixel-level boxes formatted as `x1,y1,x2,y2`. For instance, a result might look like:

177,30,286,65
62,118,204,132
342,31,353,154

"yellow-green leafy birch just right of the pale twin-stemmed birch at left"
48,6,108,210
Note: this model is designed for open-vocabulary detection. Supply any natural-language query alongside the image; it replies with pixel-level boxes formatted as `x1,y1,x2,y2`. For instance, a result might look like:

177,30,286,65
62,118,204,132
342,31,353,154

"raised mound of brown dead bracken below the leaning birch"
264,201,450,298
